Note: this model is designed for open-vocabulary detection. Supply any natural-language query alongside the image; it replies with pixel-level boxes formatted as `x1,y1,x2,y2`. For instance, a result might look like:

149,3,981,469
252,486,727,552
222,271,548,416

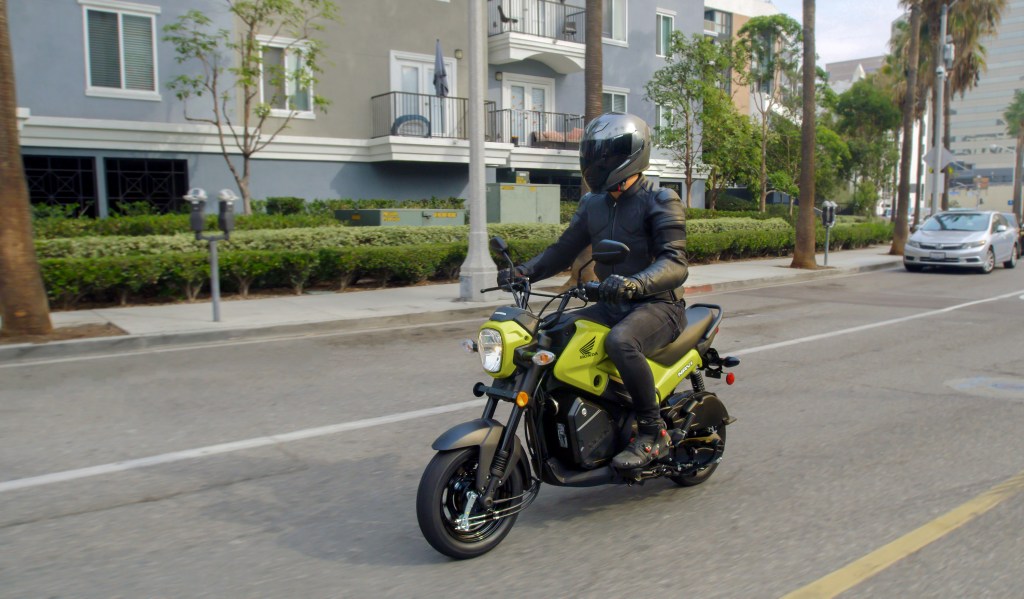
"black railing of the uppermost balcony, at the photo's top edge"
487,0,587,44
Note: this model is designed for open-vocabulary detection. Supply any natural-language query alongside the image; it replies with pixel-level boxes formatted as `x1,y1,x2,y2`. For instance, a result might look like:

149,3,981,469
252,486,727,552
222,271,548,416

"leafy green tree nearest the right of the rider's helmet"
645,32,735,208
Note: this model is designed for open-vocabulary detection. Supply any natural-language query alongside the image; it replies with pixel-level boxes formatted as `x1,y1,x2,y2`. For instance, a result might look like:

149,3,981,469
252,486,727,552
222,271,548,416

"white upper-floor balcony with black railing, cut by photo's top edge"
487,0,587,75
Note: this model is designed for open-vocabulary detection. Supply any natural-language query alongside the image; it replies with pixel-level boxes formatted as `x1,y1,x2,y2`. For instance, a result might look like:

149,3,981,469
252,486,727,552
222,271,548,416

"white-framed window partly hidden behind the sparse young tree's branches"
257,36,313,119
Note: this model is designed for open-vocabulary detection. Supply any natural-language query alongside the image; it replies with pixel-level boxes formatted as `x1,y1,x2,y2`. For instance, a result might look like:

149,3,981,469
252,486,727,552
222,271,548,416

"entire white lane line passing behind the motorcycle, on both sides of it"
0,290,1024,493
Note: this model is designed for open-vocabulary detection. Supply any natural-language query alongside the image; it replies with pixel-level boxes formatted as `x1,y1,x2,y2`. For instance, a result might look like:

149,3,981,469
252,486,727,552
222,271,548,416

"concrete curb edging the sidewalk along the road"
0,262,899,362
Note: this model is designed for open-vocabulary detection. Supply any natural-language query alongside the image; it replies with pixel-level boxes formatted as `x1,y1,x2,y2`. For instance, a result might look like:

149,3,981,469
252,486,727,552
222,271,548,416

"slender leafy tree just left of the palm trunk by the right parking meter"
737,14,802,212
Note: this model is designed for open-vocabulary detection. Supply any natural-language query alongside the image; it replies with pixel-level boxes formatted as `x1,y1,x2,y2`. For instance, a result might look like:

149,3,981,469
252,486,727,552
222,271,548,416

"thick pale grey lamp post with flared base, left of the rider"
459,0,498,302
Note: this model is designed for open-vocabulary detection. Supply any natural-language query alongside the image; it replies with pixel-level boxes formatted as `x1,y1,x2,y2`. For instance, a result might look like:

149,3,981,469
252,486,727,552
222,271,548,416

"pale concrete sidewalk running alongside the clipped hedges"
0,246,901,362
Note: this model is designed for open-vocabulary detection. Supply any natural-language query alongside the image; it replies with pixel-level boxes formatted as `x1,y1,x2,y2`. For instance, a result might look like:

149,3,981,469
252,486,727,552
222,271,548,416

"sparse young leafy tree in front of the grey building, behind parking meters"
164,0,337,214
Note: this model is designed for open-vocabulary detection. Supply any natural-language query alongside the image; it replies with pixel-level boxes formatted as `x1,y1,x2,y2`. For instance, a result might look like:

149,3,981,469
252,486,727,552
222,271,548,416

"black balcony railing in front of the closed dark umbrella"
370,91,496,141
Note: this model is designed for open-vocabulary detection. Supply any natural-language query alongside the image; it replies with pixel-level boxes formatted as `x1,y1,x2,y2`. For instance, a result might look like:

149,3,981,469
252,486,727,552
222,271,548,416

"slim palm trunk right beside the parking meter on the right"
790,0,818,268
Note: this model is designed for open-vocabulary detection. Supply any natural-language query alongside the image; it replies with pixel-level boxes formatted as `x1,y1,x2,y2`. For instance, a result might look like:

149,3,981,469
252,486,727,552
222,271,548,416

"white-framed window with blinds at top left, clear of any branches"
79,0,160,100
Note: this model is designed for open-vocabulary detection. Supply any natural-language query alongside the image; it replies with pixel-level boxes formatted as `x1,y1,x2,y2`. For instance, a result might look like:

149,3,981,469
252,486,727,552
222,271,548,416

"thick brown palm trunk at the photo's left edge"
0,0,53,337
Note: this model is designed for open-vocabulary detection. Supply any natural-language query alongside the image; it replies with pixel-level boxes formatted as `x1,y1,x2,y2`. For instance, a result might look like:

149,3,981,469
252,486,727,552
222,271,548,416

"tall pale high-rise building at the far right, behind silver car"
949,0,1024,210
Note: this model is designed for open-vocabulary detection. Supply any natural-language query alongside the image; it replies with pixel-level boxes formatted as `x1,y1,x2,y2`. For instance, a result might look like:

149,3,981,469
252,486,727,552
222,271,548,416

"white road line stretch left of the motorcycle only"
0,399,484,493
